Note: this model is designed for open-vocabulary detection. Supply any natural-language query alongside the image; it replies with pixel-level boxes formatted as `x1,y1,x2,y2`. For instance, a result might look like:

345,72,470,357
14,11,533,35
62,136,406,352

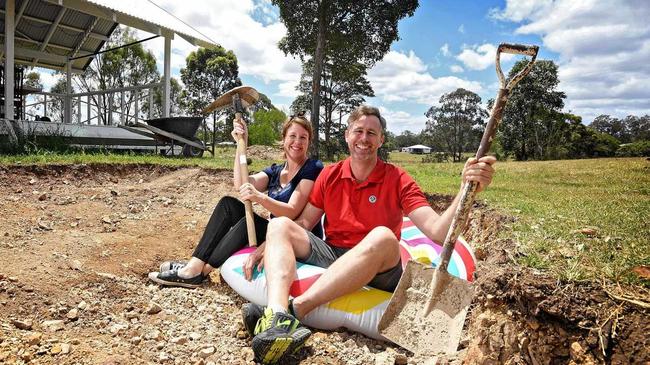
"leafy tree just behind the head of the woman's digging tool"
181,46,241,139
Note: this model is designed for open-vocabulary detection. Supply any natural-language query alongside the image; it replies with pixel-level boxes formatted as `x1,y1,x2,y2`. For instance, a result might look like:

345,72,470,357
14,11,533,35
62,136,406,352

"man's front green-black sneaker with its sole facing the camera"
253,308,311,364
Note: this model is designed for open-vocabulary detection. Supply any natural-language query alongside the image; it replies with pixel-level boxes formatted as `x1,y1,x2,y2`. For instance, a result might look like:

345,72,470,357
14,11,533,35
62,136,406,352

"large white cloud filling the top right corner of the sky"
491,0,650,121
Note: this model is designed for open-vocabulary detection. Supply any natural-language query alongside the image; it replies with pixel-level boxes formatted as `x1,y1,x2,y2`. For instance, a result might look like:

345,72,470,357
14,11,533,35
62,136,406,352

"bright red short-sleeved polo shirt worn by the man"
309,157,429,248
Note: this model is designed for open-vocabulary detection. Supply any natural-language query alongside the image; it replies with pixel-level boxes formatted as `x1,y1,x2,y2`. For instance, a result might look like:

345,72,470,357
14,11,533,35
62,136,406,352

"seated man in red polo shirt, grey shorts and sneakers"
242,106,496,362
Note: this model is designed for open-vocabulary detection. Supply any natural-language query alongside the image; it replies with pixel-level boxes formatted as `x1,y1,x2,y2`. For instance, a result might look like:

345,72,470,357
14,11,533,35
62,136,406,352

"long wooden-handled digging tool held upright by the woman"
203,86,260,247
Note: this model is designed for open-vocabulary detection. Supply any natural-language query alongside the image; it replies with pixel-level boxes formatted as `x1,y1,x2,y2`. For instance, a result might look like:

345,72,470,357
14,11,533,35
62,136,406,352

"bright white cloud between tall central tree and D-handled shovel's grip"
368,51,482,106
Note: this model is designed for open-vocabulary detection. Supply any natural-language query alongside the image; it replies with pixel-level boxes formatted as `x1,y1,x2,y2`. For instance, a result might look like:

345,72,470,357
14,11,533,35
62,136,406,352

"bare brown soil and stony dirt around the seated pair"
0,164,650,364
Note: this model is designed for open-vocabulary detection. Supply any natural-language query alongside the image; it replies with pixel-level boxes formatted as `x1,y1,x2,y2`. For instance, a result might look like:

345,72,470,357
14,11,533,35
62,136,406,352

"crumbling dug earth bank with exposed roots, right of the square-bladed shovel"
430,196,650,364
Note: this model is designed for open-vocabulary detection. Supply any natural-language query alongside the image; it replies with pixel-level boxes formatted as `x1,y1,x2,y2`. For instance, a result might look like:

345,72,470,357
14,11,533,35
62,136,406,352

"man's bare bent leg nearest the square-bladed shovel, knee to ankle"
286,227,400,318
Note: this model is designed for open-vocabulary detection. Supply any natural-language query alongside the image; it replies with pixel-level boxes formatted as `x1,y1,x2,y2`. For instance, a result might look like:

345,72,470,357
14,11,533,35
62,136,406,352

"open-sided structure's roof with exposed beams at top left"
0,0,214,72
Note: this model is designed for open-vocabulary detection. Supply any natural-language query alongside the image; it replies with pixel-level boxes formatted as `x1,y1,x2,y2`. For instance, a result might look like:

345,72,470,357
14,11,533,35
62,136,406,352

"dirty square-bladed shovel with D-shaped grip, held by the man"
378,44,539,355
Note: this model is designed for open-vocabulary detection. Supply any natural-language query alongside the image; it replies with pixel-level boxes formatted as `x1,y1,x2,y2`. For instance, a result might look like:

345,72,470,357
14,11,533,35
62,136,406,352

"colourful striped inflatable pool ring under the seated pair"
221,218,476,340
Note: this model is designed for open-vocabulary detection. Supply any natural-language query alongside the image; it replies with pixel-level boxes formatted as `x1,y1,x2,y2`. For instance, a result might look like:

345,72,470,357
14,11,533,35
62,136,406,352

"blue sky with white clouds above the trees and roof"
38,0,650,134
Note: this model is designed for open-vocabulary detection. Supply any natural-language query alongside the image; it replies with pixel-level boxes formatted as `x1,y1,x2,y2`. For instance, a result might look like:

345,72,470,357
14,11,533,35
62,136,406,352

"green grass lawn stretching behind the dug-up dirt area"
0,149,650,285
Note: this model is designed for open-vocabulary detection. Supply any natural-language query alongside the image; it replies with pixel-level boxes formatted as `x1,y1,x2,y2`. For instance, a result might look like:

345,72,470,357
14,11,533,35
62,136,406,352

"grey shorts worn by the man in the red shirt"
298,231,402,292
